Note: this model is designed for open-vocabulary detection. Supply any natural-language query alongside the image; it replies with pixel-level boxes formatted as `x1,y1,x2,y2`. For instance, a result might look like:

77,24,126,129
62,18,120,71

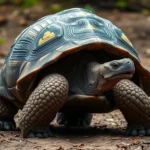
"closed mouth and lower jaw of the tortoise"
111,70,135,79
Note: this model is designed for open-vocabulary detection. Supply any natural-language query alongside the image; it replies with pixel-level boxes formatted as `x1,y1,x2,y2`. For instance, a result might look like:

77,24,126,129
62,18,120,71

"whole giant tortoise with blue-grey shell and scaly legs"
0,8,150,137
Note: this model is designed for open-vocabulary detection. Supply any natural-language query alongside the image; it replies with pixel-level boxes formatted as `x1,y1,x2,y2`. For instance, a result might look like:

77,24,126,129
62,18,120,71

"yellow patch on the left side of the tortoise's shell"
38,31,55,45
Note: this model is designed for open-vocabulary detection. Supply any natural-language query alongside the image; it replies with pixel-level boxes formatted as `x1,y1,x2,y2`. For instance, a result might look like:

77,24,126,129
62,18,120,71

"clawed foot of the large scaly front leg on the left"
24,128,52,138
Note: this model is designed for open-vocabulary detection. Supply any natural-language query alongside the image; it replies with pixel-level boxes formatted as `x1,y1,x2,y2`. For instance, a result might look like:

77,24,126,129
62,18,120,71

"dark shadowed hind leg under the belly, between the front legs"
57,112,93,127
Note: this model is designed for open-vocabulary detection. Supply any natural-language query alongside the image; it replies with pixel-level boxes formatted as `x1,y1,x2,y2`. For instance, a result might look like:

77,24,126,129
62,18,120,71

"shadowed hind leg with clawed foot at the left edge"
0,97,18,130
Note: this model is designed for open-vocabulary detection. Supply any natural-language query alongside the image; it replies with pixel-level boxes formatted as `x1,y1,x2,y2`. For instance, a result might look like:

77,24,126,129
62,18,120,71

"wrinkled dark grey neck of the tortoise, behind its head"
67,55,105,95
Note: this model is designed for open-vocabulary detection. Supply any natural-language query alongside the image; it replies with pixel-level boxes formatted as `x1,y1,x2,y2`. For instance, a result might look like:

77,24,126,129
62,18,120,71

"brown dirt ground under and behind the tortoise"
0,6,150,150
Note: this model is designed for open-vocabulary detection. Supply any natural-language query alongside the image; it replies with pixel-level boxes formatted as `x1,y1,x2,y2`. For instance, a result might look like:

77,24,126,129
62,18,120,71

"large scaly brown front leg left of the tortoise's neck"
19,74,68,138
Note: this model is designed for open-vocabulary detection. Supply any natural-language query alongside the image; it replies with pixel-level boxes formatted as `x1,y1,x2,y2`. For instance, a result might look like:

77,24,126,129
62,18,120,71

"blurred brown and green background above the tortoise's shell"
0,0,150,70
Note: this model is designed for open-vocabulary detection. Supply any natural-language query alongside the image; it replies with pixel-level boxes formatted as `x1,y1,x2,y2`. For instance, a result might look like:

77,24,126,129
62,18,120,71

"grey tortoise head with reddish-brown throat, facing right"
99,58,135,92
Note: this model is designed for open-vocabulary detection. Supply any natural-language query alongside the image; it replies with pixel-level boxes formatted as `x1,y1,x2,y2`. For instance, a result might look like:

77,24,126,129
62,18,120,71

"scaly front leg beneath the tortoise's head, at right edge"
113,80,150,136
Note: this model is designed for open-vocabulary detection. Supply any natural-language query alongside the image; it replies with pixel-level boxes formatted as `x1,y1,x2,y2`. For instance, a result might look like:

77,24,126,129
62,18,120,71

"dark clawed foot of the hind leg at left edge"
0,119,16,131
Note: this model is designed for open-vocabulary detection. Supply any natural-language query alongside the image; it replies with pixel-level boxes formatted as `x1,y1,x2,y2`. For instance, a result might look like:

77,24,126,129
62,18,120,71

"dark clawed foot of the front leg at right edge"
126,126,150,136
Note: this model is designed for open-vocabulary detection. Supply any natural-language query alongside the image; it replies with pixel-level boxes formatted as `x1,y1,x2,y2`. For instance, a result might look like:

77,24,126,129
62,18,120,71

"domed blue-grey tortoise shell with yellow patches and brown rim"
0,8,150,102
